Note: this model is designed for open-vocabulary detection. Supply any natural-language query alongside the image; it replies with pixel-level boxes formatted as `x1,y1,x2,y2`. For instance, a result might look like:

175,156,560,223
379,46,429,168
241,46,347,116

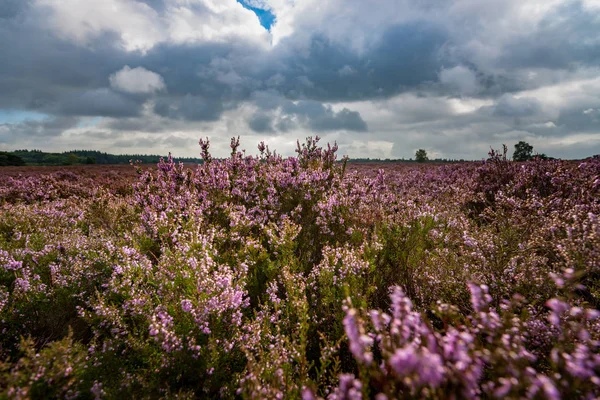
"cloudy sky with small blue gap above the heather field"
0,0,600,160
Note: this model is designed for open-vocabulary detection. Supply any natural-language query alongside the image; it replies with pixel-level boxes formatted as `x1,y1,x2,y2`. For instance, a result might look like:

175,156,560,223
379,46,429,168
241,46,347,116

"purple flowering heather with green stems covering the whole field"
0,139,600,400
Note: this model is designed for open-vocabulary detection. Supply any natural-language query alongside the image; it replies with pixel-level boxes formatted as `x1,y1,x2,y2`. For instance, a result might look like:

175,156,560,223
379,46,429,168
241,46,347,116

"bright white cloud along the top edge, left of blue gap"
35,0,270,52
